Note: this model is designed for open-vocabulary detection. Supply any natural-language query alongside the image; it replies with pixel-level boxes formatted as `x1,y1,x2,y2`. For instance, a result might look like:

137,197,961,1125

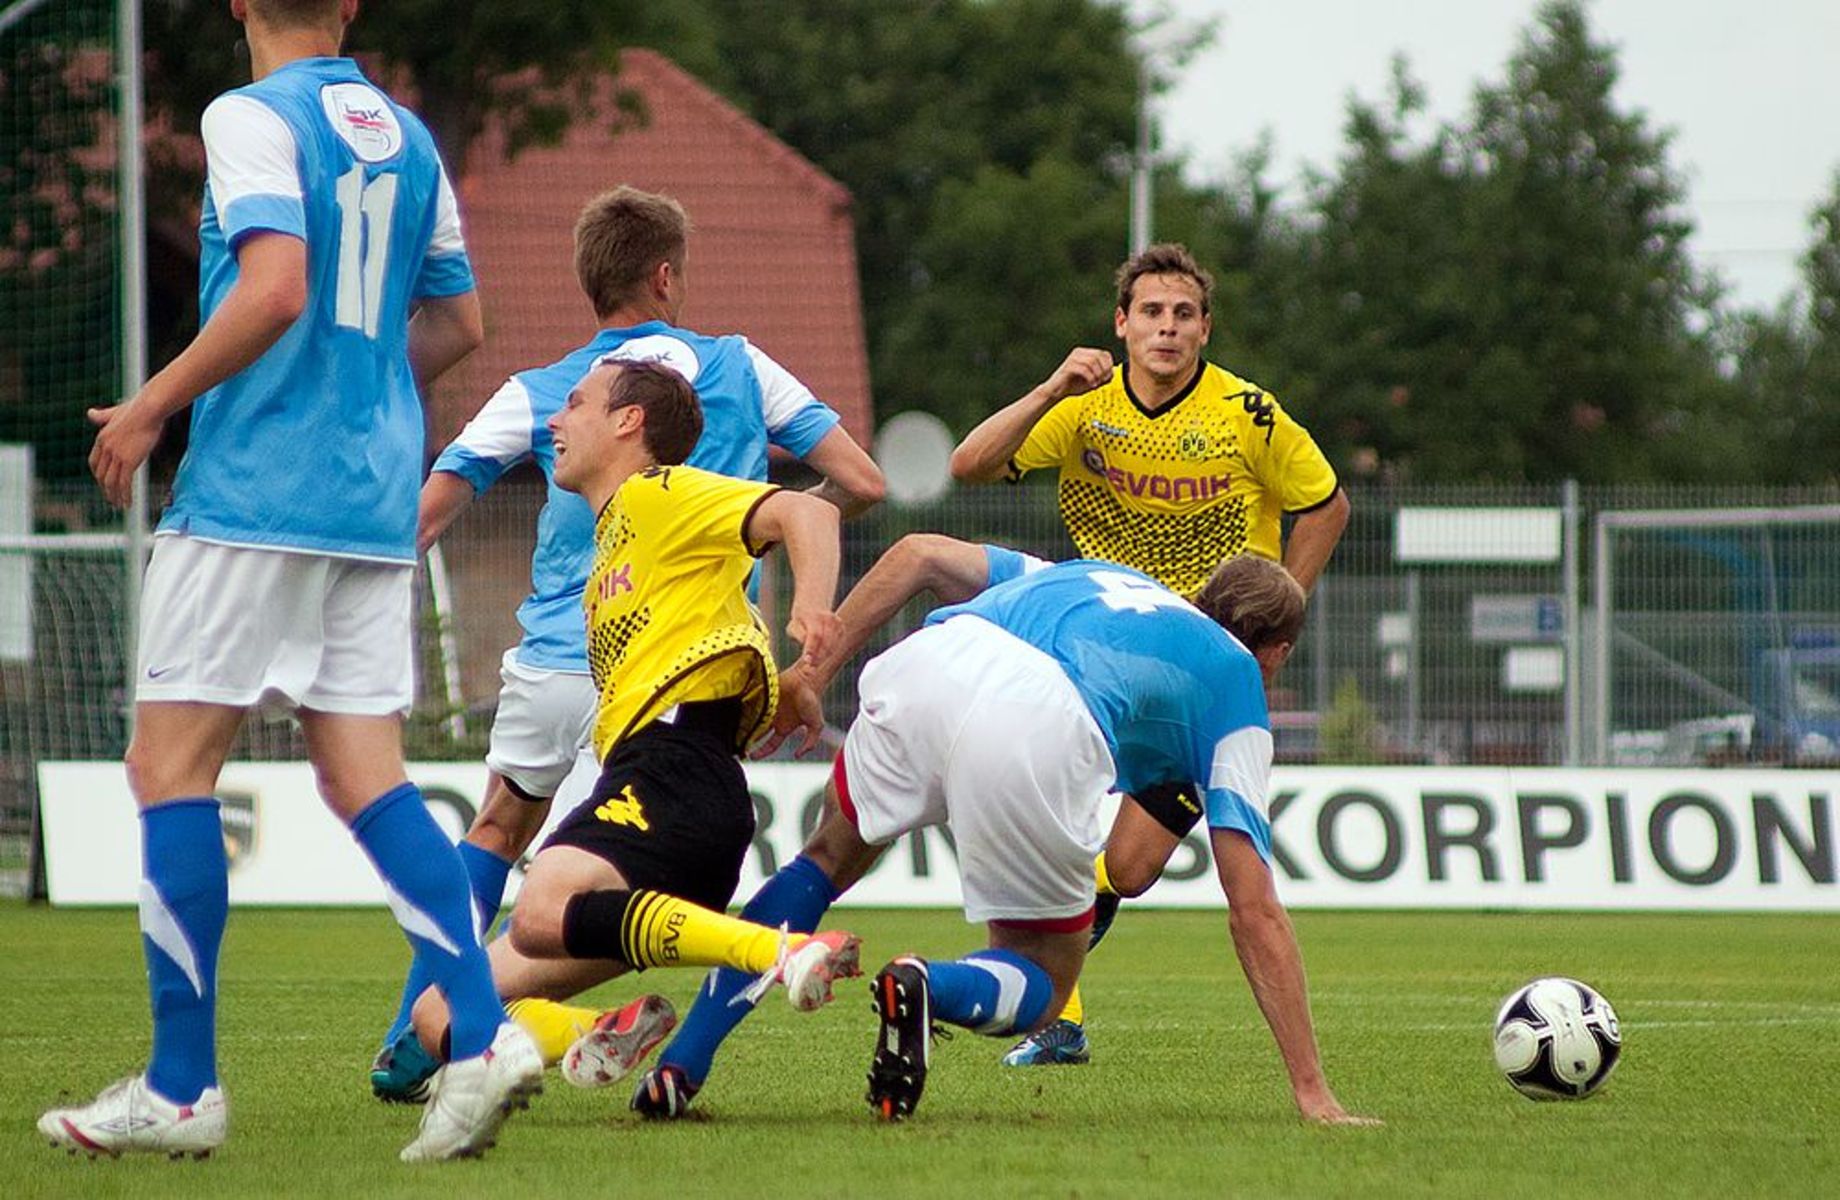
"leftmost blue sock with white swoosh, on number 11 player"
140,795,230,1104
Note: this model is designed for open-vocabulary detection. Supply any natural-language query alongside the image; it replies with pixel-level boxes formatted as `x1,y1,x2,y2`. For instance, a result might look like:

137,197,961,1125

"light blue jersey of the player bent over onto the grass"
927,559,1271,860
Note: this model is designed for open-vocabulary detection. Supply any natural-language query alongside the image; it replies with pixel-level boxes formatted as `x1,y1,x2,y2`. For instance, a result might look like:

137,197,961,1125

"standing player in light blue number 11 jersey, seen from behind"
39,0,543,1161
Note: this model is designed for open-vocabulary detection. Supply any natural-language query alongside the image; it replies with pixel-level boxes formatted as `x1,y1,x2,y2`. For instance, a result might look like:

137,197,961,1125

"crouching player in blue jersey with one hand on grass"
648,534,1369,1125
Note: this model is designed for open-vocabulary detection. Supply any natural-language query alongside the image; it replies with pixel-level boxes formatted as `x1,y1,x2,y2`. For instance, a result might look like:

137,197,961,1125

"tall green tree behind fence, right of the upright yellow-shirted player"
1279,0,1731,482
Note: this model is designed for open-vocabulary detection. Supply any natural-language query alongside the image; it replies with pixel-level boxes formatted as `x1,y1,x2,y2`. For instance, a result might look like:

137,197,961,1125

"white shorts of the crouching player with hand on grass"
843,617,1117,922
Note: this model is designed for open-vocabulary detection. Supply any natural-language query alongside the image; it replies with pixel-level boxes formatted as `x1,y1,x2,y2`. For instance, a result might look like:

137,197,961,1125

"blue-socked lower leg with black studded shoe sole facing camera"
868,950,1054,1121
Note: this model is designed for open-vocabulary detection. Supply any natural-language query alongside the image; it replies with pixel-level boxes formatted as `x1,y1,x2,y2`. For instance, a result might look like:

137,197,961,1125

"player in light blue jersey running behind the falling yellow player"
372,188,883,1101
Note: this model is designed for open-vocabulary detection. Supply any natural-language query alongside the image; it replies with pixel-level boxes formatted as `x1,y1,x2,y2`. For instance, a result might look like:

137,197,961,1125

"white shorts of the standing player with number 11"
134,534,414,716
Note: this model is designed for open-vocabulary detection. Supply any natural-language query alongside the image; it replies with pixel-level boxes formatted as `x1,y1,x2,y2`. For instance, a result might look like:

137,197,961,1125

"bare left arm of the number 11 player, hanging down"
88,234,307,508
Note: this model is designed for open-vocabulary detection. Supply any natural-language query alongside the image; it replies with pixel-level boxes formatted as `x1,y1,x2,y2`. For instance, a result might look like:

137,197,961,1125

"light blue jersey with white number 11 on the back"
160,59,473,563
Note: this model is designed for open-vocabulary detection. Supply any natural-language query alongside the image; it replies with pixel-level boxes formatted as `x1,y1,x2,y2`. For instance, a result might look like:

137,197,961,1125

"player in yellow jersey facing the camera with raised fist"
951,243,1349,1066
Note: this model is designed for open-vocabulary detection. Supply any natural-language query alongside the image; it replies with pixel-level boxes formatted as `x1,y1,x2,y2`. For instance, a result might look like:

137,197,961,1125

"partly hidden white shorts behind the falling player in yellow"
486,646,600,797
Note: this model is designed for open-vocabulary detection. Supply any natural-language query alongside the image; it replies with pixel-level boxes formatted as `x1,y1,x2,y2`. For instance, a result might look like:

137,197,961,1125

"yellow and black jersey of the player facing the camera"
1010,363,1336,596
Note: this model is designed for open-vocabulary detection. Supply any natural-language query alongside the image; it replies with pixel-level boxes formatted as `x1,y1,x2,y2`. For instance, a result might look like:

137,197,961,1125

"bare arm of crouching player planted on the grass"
1213,830,1380,1125
